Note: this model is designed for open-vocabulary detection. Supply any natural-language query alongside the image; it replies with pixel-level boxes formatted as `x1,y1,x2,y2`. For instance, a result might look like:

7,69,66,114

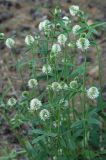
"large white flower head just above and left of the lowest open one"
29,98,42,111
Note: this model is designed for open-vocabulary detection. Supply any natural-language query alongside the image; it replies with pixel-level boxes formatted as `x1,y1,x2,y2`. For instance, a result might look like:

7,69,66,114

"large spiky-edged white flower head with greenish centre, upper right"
76,38,90,50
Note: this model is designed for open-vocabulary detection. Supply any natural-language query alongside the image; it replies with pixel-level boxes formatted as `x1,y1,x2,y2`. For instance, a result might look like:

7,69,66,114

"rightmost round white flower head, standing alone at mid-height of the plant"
87,87,99,99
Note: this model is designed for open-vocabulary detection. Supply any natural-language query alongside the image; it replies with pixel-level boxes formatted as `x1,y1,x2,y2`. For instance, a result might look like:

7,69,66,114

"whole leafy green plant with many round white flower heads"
1,5,106,160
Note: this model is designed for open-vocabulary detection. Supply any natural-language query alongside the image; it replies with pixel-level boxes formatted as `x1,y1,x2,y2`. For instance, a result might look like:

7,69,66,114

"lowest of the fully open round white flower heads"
39,109,50,121
